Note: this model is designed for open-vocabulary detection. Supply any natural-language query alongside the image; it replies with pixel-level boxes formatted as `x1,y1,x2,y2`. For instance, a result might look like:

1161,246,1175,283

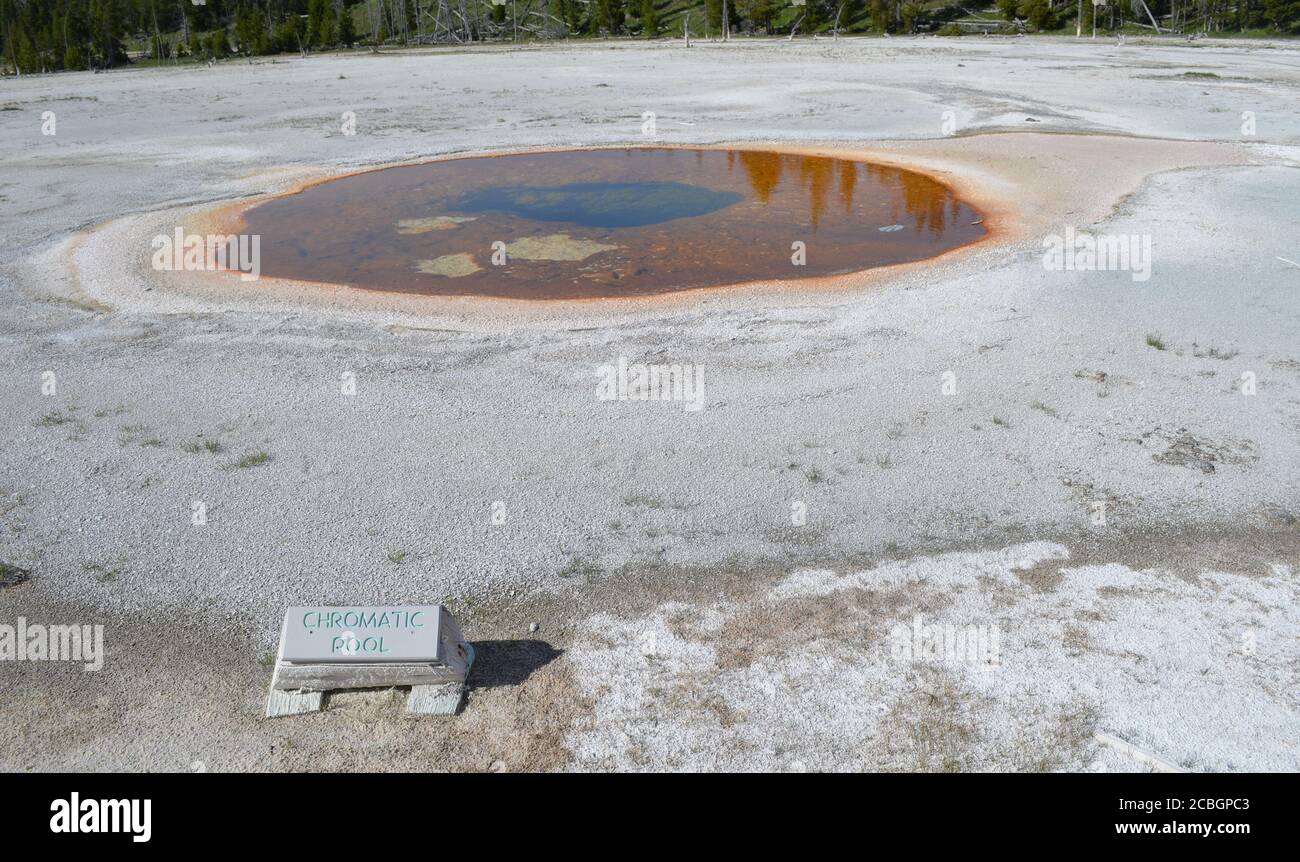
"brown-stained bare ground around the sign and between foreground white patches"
0,527,1300,771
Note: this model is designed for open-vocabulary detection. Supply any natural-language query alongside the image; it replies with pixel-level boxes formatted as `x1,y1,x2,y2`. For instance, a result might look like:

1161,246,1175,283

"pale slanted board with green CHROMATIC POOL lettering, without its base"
280,605,442,664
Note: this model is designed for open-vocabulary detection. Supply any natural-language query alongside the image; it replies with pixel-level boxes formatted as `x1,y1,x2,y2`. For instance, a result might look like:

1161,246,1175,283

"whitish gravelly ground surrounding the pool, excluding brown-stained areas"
0,39,1300,770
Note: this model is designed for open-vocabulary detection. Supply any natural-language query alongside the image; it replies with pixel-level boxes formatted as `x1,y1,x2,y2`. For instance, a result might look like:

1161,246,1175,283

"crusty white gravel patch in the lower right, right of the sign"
571,542,1300,771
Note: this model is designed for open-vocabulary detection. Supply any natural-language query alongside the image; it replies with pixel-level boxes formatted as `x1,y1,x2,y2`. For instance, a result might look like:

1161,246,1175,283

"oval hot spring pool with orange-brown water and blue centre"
242,148,985,299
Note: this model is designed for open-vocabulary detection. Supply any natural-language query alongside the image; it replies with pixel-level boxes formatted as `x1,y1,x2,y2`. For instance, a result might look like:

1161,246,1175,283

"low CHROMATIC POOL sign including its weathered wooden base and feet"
267,605,475,718
